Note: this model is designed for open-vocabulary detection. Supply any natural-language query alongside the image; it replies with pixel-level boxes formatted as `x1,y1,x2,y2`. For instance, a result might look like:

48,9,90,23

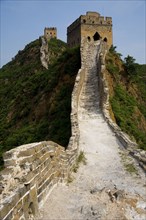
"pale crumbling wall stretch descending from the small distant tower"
40,36,49,69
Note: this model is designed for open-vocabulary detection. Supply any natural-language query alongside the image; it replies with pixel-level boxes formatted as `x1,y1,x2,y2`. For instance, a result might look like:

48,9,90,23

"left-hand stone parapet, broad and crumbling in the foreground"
0,37,85,220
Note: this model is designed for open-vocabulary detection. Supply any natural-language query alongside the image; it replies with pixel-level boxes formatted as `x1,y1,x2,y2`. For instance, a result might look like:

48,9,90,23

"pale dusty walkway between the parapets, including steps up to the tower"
40,41,146,220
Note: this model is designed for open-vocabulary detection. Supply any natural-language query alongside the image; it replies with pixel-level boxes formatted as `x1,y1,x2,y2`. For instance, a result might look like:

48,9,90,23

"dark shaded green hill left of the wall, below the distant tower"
0,39,81,168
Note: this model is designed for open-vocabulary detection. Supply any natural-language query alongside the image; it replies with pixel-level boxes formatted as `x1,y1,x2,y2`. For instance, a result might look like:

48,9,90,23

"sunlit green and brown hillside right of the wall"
106,47,146,150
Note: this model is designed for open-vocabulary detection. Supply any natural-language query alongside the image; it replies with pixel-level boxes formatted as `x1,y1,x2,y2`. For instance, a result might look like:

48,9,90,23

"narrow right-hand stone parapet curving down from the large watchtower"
98,42,146,171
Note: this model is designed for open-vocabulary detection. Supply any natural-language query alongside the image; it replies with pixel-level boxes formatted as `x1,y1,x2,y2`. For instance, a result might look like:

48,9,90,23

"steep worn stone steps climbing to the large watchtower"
79,42,99,118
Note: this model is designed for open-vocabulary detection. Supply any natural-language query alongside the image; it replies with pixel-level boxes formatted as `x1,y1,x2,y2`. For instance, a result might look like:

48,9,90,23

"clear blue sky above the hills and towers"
0,0,146,67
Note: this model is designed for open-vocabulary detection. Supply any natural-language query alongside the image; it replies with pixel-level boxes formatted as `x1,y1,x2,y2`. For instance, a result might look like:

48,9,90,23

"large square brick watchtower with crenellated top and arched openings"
67,12,113,47
